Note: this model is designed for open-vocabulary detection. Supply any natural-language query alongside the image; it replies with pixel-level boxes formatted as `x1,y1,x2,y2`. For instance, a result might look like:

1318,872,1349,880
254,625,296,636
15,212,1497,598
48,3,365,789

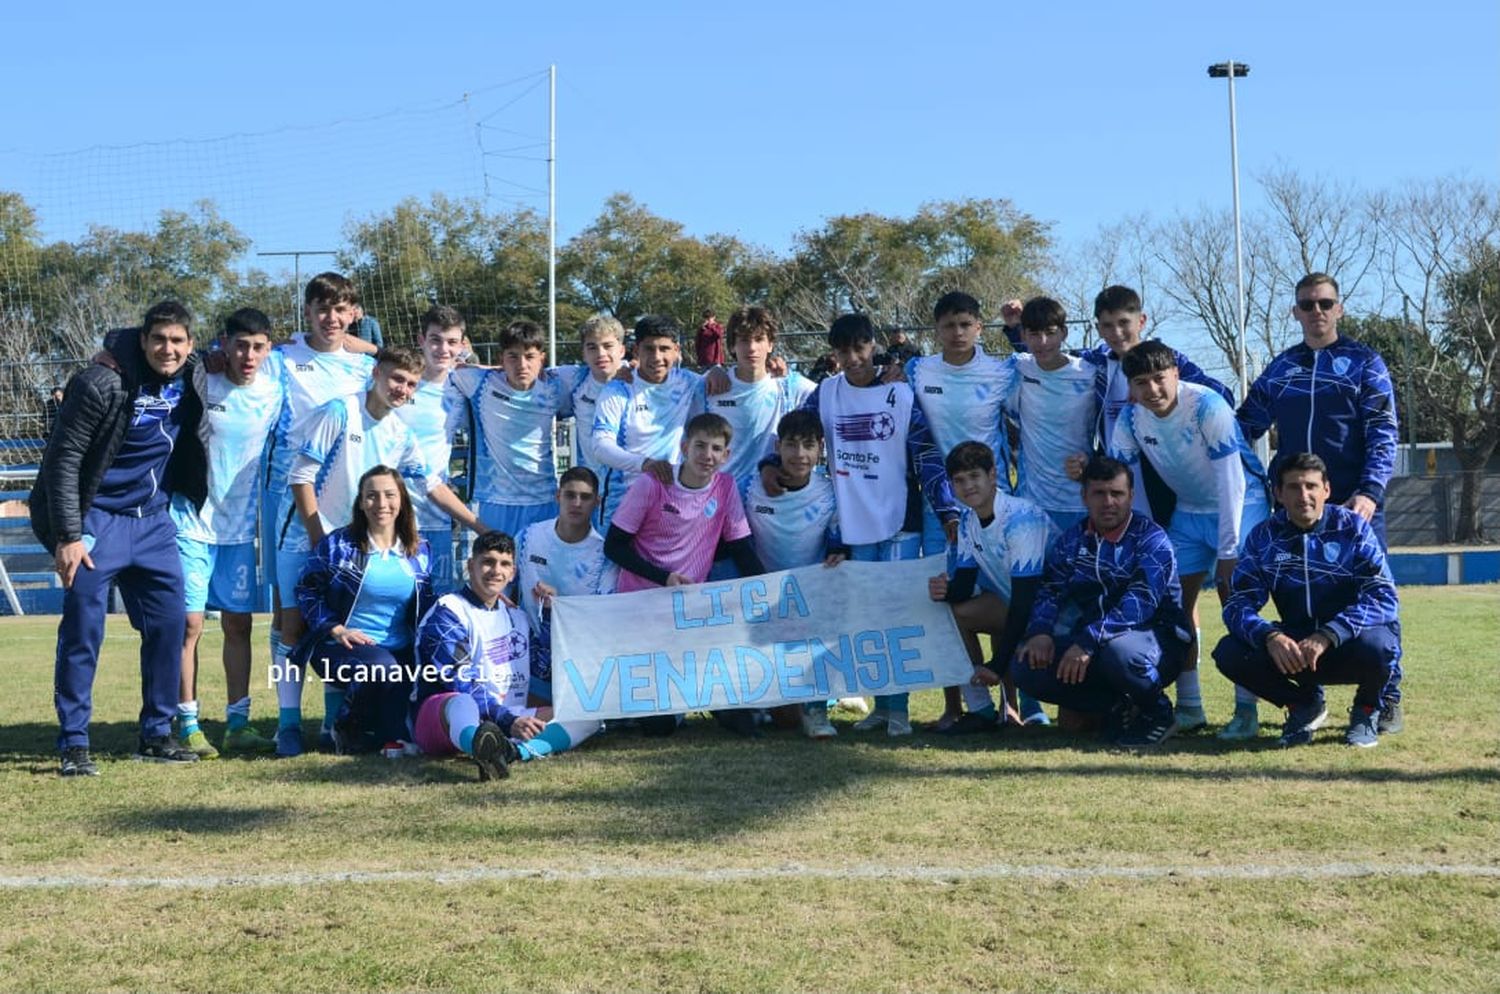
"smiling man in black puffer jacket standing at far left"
30,301,207,777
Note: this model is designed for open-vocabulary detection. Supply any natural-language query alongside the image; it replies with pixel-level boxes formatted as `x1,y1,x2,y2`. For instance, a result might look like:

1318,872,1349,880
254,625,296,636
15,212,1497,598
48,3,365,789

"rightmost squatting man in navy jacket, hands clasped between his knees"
1214,453,1401,748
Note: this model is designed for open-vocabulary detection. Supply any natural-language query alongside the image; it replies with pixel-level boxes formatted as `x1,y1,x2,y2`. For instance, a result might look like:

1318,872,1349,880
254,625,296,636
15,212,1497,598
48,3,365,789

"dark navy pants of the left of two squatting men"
1011,631,1188,712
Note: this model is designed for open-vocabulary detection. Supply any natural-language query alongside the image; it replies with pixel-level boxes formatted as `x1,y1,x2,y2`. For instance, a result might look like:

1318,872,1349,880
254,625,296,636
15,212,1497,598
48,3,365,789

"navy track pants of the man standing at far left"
53,510,186,750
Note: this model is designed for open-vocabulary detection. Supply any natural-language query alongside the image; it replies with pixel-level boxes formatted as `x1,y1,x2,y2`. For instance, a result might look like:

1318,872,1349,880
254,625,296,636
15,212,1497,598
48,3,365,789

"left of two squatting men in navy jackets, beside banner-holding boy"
1011,456,1193,747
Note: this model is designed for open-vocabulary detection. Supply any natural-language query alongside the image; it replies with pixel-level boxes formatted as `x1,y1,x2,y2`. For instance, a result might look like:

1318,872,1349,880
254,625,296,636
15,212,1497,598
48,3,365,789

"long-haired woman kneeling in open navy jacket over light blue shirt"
288,466,432,756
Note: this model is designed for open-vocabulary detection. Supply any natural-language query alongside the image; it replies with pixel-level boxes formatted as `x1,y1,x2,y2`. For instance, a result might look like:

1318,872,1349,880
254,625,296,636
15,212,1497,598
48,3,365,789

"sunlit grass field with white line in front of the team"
0,586,1500,991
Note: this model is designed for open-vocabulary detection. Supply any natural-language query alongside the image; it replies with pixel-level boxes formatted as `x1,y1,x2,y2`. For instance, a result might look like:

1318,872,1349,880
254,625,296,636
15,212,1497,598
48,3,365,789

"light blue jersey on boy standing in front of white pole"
449,366,573,505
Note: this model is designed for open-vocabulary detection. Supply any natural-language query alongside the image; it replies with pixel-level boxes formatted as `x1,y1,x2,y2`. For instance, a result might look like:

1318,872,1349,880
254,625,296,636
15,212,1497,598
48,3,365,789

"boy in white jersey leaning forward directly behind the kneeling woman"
276,349,485,757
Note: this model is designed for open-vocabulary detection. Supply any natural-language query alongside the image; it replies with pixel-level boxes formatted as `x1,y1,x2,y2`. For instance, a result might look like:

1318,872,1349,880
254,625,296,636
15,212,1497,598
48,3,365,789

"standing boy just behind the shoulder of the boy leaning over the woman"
396,306,468,597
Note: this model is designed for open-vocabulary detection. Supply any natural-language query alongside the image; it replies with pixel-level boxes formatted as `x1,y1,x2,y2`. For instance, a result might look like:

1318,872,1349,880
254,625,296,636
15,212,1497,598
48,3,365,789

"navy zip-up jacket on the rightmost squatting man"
1224,501,1400,646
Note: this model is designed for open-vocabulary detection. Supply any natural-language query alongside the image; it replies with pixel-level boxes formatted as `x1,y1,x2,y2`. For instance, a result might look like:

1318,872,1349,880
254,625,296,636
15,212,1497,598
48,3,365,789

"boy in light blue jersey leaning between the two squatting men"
1110,342,1271,739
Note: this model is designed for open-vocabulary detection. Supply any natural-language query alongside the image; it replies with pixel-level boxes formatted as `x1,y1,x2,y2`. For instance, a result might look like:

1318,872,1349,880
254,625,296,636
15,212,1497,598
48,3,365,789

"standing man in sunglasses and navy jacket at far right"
1238,273,1401,735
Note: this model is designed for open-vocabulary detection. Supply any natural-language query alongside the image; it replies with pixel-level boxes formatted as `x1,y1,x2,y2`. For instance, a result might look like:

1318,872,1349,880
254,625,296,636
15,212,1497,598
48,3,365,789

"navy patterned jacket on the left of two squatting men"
1026,514,1191,652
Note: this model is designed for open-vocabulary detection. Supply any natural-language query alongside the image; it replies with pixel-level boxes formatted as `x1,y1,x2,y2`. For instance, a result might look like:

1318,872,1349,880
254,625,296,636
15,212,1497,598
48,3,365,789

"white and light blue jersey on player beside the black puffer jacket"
173,361,287,546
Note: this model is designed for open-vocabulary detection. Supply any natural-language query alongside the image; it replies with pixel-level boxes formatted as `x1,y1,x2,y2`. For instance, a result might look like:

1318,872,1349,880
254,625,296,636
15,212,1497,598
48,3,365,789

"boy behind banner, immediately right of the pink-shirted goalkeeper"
744,410,849,739
